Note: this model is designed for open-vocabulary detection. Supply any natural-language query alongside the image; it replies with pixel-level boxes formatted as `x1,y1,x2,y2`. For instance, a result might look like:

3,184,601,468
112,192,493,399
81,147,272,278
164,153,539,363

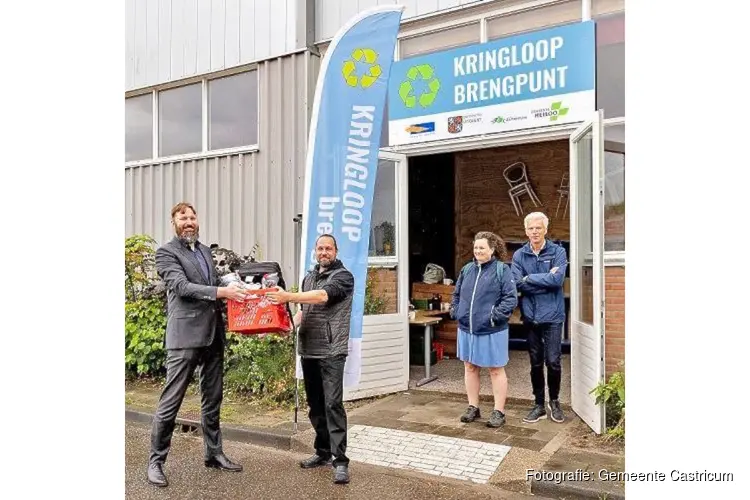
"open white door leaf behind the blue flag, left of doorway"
344,151,409,401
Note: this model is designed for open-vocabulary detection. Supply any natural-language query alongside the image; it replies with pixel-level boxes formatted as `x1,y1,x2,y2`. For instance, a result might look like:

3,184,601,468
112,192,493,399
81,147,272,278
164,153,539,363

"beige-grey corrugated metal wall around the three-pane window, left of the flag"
125,52,319,283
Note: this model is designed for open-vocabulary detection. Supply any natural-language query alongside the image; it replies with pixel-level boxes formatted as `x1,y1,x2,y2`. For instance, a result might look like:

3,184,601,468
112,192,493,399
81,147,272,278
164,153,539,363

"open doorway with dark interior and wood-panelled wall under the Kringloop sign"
408,139,571,405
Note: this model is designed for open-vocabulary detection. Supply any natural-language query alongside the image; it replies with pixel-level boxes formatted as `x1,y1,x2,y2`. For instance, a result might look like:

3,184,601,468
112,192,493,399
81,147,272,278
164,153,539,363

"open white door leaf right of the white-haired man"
570,111,605,434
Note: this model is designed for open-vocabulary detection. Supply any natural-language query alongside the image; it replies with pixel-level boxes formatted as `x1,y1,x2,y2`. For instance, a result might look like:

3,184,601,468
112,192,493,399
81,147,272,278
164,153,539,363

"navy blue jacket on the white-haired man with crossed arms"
511,240,568,323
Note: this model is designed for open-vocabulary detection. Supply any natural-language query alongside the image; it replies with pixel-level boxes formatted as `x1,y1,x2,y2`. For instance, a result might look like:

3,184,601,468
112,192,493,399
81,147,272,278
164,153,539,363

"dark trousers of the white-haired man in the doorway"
526,323,563,405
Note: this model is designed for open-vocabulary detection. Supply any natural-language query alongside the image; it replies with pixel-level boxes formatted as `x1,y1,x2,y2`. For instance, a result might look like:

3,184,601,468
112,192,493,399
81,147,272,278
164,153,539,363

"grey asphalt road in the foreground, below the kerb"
125,423,542,500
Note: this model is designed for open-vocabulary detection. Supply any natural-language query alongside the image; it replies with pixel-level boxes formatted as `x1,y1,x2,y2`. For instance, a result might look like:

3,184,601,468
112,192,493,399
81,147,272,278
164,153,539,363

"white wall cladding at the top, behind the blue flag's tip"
315,0,490,40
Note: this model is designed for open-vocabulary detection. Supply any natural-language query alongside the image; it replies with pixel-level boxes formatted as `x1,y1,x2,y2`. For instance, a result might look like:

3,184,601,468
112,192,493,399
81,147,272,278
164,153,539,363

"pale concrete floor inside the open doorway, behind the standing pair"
409,350,570,406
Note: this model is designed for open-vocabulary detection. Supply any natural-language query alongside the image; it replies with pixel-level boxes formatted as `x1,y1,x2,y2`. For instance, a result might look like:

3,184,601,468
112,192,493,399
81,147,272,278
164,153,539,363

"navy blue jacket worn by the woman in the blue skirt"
451,257,518,335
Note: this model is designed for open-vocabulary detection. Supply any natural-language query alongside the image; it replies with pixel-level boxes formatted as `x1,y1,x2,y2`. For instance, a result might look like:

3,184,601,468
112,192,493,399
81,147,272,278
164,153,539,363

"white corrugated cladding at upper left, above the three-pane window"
125,0,305,91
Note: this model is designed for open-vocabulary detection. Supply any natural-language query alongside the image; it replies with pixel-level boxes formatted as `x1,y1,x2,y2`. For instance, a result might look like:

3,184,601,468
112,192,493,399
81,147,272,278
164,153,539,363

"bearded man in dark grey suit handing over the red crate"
148,203,246,486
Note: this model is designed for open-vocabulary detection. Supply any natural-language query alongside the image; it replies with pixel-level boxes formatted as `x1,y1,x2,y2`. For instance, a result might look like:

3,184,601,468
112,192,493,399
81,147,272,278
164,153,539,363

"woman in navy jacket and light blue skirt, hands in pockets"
451,231,518,427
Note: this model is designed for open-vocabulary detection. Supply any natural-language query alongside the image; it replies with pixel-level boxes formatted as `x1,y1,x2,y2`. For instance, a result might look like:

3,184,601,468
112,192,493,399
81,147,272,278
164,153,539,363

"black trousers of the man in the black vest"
302,355,349,466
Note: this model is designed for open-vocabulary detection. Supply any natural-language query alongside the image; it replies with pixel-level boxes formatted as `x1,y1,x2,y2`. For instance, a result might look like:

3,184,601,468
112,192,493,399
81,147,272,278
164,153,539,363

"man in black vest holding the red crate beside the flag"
267,234,354,484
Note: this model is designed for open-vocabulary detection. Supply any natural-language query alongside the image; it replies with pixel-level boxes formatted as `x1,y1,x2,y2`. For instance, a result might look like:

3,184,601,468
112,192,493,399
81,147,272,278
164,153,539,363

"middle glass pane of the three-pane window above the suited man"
159,83,203,156
